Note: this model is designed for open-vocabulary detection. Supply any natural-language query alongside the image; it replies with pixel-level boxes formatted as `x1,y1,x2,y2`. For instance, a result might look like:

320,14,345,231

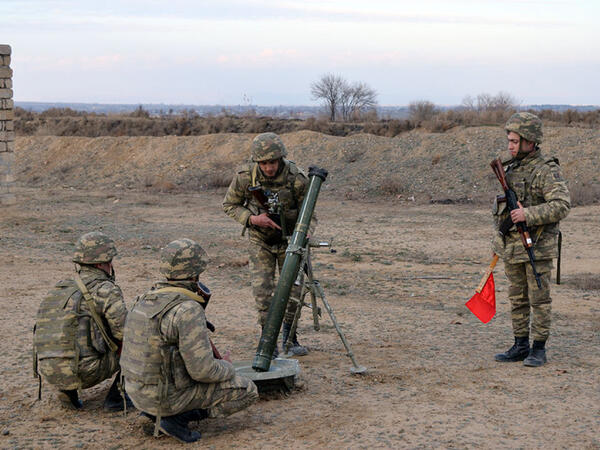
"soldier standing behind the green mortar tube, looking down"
223,133,316,356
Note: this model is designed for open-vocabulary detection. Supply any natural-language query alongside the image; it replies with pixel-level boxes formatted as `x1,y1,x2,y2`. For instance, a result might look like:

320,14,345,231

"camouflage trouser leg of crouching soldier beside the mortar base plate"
181,375,258,417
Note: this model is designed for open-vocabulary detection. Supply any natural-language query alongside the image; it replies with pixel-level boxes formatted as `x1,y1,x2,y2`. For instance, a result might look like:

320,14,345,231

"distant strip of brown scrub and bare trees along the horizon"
14,92,600,137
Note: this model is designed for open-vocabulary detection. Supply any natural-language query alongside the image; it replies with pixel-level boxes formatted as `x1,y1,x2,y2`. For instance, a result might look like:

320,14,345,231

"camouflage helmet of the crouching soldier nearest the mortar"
159,239,208,280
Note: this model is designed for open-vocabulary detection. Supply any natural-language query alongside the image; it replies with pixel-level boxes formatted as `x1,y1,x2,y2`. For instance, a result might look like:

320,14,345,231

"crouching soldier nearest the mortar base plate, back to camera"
121,239,258,442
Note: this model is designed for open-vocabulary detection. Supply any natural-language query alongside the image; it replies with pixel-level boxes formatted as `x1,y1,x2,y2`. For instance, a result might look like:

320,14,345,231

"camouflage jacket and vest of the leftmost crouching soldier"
34,266,127,389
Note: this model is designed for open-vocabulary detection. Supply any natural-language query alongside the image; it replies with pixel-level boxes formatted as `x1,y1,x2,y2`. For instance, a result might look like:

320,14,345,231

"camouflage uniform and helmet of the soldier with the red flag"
493,113,570,342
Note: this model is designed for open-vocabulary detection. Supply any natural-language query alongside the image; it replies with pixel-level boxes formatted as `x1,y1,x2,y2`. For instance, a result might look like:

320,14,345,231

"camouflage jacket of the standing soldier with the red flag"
492,150,571,264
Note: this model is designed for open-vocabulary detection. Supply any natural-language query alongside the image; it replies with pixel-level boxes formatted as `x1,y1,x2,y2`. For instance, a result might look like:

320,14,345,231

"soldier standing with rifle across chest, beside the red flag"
492,112,571,367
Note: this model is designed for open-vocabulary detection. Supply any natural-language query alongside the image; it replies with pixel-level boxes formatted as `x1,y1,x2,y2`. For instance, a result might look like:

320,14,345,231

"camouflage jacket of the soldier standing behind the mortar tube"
223,159,317,246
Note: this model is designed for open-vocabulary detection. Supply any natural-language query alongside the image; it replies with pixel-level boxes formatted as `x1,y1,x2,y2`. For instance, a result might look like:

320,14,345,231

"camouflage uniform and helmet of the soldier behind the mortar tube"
223,133,317,325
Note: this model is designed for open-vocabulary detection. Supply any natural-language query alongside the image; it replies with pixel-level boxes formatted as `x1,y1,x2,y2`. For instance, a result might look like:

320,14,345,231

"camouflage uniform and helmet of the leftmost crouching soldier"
34,233,127,390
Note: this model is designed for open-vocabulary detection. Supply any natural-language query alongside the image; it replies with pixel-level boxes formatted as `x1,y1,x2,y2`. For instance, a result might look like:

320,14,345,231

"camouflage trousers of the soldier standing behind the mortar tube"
249,242,301,326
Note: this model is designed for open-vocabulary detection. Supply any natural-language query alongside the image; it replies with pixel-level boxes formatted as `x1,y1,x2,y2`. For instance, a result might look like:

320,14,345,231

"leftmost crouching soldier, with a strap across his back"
33,232,127,411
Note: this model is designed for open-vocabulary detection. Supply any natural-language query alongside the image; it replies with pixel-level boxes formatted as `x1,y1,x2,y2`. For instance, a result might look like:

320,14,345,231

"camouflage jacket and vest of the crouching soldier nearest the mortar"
121,281,235,415
